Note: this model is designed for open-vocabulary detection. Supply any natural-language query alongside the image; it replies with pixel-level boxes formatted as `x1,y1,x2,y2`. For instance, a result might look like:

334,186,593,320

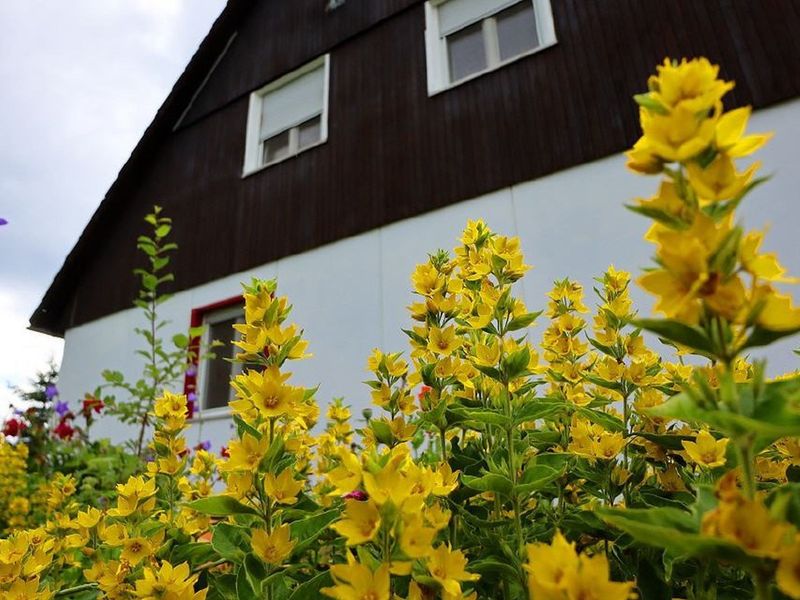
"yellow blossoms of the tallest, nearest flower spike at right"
628,59,800,331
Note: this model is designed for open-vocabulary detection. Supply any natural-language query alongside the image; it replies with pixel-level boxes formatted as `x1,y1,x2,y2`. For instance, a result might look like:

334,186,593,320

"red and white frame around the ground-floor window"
183,295,244,422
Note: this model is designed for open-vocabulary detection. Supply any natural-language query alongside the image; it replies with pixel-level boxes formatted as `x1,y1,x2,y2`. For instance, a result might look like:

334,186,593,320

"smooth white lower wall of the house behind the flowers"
59,100,800,448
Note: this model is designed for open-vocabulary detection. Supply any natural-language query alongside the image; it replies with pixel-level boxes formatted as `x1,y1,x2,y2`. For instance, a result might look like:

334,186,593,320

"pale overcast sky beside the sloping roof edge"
0,0,225,415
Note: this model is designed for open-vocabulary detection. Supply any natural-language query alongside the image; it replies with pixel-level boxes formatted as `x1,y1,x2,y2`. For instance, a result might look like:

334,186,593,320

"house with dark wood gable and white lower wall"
31,0,800,445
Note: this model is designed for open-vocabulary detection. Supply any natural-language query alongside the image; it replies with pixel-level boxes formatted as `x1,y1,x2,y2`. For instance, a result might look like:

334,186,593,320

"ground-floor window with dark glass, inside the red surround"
198,305,244,415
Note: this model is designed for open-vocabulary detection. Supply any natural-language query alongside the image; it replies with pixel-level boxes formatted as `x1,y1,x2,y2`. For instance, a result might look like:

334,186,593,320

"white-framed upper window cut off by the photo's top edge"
425,0,556,95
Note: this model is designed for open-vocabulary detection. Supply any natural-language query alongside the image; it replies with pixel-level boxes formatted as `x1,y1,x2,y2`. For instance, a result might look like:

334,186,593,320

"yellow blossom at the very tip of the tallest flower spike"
647,58,733,113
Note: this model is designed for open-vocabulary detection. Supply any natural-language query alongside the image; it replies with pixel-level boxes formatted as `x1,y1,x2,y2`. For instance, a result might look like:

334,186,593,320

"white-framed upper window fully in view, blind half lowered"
243,54,330,175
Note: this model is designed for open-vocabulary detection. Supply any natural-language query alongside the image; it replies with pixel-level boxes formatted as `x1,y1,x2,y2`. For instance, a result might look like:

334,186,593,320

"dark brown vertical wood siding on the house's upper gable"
32,0,800,332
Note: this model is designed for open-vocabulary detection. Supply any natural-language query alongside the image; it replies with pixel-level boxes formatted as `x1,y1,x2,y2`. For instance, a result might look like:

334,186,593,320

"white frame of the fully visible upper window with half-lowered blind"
242,53,330,177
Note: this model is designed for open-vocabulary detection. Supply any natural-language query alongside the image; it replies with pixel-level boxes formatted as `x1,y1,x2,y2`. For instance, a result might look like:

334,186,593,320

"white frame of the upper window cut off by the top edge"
425,0,558,96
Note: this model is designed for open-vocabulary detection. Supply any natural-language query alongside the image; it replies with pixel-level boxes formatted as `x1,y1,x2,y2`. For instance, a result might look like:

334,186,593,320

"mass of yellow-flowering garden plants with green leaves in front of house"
0,59,800,600
